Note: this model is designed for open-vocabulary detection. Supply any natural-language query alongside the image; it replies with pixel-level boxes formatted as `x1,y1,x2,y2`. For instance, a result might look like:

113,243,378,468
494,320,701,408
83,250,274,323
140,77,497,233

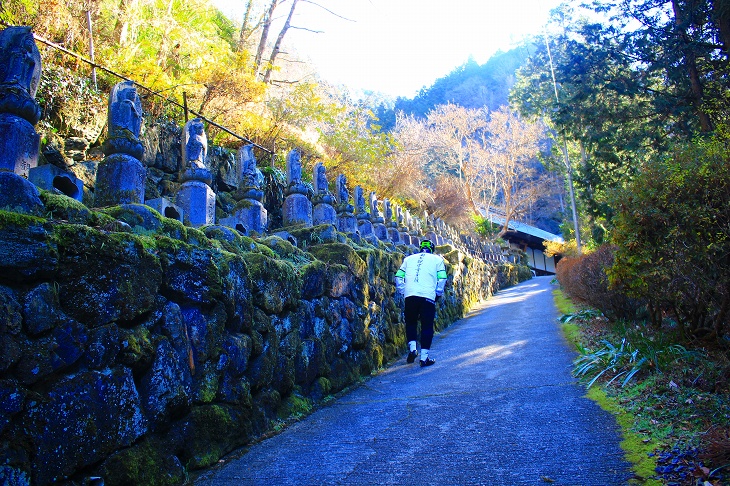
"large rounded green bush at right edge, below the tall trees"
609,140,730,338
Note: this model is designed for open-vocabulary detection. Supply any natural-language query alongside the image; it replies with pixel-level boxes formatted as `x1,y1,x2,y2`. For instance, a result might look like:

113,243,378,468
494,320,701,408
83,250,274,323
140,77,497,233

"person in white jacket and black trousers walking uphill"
395,240,446,366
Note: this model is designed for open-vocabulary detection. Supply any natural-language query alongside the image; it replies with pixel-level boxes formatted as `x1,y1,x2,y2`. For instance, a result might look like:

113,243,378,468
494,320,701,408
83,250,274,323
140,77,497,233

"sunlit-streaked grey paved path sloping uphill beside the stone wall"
196,277,631,486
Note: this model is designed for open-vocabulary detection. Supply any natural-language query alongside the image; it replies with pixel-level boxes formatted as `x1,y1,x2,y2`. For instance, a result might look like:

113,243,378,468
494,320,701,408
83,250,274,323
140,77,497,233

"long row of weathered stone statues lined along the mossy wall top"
0,27,498,259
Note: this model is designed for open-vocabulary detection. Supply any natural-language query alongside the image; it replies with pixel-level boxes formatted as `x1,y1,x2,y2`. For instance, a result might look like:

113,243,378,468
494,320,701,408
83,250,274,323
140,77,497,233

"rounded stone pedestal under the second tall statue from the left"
94,154,147,206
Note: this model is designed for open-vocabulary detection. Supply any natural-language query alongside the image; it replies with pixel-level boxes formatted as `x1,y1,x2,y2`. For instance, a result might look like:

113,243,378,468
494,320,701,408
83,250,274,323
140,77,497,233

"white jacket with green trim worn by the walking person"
395,252,446,300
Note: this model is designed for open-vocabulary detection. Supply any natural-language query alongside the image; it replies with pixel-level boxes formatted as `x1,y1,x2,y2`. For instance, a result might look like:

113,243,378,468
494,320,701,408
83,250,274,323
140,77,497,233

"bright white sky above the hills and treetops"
213,0,558,98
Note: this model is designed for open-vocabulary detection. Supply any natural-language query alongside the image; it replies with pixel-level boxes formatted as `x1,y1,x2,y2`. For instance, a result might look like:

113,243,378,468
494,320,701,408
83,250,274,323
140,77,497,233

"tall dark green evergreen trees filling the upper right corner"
510,0,730,237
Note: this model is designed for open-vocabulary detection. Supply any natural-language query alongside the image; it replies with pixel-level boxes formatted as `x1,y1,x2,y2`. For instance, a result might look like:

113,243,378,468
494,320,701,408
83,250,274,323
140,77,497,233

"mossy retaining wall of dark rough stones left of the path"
0,192,517,485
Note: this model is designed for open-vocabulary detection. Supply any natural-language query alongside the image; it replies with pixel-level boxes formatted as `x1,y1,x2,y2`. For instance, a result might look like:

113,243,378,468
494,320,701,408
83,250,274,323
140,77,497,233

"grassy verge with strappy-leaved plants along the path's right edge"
554,290,730,486
